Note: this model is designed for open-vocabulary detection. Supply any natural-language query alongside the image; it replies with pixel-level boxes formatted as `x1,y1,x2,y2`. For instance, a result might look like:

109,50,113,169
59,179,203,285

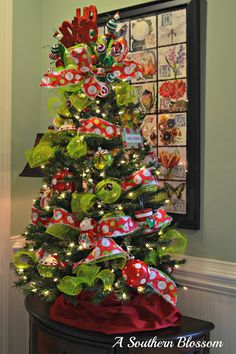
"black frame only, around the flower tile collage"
98,0,204,230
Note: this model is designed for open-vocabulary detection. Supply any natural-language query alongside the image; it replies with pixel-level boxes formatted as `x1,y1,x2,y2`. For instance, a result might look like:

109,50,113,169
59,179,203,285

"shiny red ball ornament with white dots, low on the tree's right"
122,259,149,288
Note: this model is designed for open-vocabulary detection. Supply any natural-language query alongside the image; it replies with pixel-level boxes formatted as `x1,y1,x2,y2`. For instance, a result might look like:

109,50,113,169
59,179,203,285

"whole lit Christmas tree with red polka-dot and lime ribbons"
14,6,186,332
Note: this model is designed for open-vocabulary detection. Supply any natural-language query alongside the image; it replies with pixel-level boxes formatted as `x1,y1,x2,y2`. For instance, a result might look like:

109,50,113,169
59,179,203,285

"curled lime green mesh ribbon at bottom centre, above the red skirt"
57,264,115,296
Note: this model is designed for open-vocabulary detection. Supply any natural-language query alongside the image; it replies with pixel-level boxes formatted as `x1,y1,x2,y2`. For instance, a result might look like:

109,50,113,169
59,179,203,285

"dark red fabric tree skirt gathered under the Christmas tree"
50,293,181,334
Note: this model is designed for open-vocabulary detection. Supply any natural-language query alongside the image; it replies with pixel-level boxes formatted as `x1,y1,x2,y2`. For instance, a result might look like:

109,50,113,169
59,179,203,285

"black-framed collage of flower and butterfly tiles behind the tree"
98,0,200,229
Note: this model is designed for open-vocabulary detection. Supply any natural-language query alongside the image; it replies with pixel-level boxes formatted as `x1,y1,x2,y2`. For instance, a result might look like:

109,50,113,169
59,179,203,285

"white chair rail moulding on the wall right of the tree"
175,256,236,296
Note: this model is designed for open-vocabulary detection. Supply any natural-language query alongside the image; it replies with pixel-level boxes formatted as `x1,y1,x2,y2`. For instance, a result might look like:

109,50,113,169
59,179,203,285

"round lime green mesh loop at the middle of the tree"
95,179,121,204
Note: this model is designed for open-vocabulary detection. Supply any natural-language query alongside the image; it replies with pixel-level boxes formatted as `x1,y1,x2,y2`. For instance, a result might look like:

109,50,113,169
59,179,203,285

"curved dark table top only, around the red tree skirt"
25,296,214,343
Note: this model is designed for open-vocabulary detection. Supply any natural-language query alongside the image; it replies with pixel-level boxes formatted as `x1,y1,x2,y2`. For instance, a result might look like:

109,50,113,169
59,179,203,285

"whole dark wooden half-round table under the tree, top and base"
25,297,214,354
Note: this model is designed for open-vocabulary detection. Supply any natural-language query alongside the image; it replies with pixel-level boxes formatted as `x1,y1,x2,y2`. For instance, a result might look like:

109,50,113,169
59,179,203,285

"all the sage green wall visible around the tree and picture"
12,0,236,261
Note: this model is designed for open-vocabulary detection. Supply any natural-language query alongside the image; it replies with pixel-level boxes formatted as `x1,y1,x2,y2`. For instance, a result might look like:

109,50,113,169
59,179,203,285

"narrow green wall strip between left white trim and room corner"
12,0,42,235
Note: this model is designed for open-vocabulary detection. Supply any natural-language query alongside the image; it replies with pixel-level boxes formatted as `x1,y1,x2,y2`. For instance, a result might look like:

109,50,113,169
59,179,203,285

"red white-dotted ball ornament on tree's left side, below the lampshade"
52,169,75,192
